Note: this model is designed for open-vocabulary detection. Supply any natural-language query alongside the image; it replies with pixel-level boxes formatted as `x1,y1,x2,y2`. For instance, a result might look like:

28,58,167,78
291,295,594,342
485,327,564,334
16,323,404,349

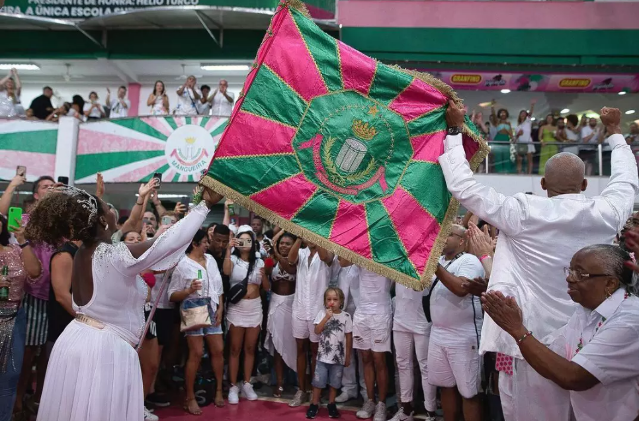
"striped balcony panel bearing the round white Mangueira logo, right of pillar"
75,116,228,184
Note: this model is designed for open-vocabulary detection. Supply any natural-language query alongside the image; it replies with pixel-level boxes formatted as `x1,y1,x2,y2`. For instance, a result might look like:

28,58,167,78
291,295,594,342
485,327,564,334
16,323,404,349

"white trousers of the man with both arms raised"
499,359,574,421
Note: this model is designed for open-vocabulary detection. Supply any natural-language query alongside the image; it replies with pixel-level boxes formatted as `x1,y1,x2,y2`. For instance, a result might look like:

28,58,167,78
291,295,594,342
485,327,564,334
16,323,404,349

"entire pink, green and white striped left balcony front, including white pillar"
0,116,228,184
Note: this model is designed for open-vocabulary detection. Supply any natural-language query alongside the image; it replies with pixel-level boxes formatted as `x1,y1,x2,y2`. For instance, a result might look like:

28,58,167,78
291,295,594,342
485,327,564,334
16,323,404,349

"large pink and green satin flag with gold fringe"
201,0,487,290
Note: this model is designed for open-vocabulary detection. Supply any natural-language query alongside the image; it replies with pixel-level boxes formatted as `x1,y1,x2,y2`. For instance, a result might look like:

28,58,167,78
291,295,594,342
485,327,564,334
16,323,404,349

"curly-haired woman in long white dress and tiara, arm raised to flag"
27,186,221,421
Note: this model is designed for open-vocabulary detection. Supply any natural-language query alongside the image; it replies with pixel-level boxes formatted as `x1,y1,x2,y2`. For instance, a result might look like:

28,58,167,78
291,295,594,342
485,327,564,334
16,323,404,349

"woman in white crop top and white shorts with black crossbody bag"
224,225,268,405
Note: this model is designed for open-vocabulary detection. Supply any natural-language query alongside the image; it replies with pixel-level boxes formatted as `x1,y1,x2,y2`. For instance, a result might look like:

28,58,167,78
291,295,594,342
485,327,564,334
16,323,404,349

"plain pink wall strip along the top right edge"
342,0,639,30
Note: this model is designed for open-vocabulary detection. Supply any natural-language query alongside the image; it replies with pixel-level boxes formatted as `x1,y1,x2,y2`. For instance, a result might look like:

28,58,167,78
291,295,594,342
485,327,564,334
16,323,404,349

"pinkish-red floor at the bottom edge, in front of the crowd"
154,399,357,421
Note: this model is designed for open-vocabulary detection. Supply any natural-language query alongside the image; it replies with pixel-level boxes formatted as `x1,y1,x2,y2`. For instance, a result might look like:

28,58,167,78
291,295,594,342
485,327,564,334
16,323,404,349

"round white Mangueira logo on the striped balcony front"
164,124,216,175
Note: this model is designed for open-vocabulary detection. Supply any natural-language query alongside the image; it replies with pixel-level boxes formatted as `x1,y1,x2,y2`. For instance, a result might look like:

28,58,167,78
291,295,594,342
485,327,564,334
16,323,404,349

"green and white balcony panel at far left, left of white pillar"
0,119,58,181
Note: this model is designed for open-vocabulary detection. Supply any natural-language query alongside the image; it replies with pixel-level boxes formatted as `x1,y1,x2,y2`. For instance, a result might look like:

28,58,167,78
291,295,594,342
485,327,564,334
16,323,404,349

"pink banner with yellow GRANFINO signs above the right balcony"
419,69,639,93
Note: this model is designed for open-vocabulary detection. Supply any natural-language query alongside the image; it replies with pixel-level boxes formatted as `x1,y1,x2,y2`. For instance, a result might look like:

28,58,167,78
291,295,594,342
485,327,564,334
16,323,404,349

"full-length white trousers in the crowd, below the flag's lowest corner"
393,331,437,412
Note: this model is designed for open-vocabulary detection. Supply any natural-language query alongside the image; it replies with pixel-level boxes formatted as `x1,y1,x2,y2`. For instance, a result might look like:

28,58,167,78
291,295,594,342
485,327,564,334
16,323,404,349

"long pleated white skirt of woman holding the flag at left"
37,321,144,421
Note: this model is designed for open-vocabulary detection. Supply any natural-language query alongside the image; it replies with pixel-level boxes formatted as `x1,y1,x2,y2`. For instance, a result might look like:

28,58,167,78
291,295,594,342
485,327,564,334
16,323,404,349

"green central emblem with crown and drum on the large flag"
293,91,412,203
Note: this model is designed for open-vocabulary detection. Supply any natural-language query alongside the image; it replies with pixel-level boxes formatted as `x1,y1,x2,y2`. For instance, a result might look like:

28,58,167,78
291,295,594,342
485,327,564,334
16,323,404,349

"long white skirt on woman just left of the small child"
264,293,297,372
